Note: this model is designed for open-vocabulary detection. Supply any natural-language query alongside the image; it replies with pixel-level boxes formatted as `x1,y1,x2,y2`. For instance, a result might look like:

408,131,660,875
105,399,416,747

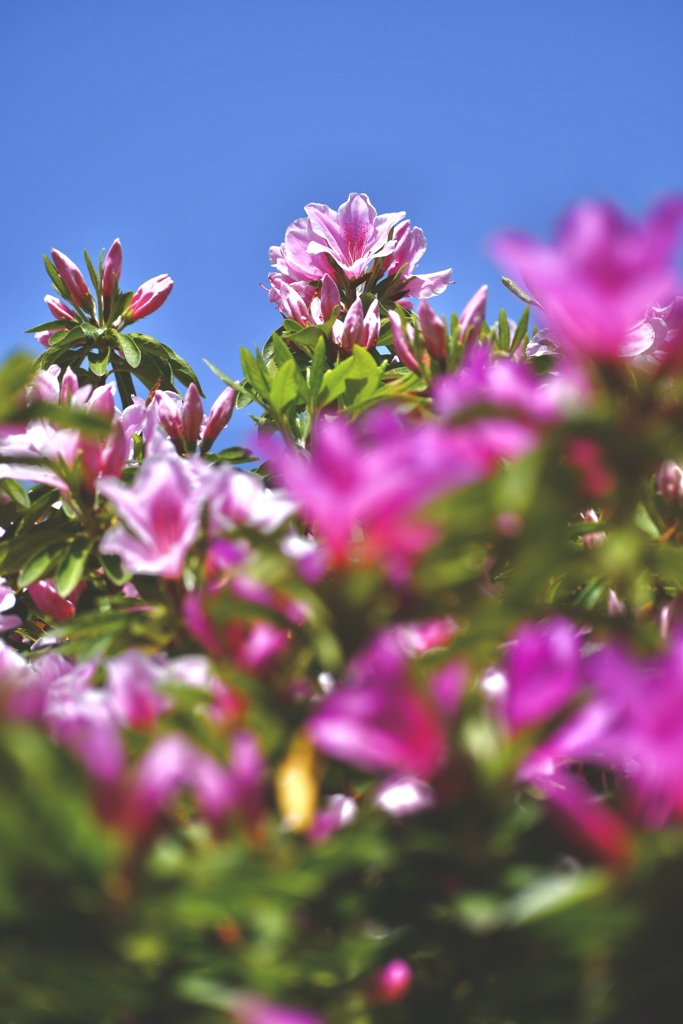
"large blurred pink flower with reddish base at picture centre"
271,411,496,573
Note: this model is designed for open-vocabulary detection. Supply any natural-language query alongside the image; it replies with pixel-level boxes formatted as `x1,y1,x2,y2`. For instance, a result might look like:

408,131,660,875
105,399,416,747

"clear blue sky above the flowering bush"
0,0,683,436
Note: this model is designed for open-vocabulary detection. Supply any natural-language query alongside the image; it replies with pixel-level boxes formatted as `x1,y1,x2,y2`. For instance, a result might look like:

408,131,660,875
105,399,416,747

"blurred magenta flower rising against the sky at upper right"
493,198,683,359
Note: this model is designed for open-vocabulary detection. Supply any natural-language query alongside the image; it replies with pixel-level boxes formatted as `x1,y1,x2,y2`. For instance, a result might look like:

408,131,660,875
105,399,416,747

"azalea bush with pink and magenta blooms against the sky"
0,194,683,1024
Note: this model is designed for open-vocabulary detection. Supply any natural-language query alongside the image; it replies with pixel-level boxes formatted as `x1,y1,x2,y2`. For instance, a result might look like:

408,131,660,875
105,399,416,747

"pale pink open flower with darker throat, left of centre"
99,457,203,580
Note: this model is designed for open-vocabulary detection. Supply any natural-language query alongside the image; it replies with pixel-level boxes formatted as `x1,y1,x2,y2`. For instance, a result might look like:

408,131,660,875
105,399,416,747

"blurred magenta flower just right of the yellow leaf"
306,635,446,778
